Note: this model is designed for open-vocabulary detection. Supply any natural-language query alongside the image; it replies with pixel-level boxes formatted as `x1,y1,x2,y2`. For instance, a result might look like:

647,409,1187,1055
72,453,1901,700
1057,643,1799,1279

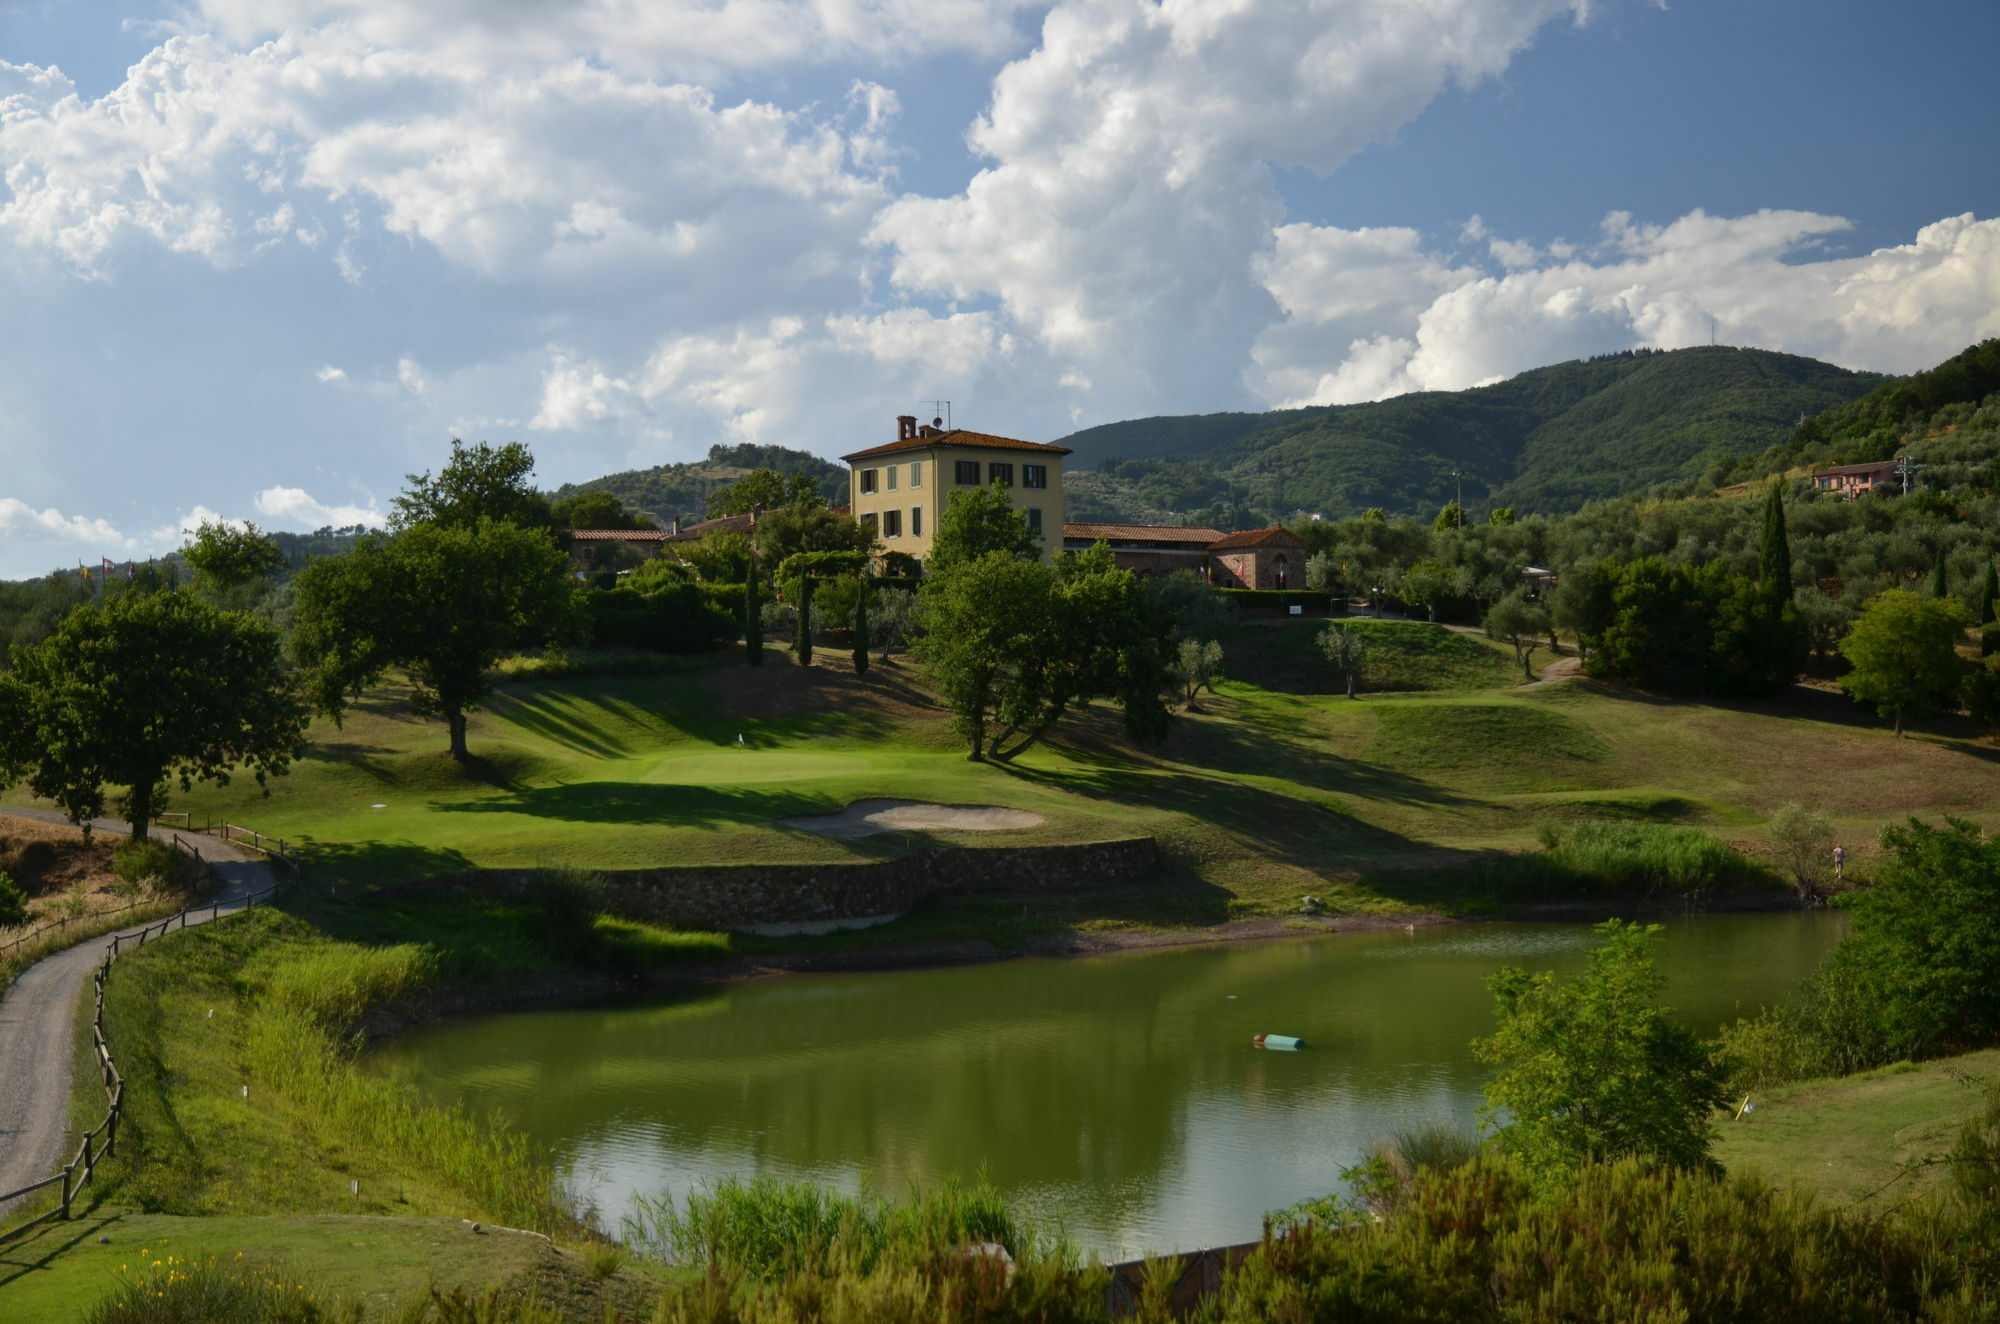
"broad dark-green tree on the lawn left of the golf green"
292,518,574,760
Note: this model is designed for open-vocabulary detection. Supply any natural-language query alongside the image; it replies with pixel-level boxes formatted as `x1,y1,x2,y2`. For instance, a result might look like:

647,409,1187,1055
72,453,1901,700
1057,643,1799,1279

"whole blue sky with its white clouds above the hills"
0,0,2000,576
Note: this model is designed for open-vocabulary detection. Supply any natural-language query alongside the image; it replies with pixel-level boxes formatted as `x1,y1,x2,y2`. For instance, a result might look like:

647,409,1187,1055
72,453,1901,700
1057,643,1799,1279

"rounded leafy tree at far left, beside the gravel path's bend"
0,592,306,840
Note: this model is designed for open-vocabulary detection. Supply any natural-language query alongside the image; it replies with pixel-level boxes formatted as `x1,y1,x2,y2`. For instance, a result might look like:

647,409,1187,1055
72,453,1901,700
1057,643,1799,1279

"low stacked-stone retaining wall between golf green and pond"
432,836,1160,928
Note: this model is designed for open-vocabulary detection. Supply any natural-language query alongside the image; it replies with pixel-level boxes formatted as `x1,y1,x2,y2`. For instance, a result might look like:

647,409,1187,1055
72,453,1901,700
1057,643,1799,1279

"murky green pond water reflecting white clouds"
376,914,1844,1256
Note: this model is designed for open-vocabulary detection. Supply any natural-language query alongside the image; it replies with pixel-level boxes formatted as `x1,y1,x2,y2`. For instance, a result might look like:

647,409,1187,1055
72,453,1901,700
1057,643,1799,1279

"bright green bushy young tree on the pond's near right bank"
1472,920,1726,1178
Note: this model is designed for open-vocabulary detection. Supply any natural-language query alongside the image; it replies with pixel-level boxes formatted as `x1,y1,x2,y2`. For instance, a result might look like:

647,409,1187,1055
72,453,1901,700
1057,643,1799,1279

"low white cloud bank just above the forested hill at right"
1256,210,2000,404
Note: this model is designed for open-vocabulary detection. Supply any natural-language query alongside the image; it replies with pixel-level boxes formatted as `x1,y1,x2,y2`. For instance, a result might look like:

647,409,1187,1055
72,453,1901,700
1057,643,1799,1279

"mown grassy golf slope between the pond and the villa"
47,620,1994,924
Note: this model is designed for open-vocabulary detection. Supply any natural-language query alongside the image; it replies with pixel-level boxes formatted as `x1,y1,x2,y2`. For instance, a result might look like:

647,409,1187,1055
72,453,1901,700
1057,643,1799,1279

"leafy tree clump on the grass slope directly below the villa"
914,546,1172,760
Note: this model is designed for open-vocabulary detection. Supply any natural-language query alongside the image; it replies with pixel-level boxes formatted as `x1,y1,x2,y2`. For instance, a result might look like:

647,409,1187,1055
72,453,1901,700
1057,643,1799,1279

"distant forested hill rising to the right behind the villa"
1062,346,1888,518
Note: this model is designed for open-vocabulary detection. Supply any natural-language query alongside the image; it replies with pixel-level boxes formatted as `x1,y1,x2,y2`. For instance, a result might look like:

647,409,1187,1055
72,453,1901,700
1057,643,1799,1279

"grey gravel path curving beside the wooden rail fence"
0,808,272,1212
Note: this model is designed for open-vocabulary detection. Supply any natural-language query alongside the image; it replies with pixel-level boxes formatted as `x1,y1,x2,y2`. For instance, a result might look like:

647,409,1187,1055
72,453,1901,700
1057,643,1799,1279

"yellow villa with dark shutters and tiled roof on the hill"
840,414,1070,560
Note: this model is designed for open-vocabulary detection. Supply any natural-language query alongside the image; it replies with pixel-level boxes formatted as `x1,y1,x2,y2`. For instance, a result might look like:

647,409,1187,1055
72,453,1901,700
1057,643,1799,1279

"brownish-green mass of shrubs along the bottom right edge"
1200,1156,1992,1324
